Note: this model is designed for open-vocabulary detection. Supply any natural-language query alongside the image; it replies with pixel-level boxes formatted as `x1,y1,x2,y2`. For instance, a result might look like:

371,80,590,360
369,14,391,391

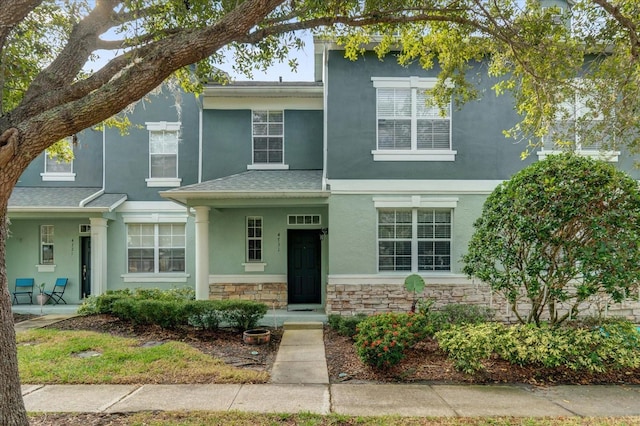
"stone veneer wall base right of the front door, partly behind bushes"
326,283,640,323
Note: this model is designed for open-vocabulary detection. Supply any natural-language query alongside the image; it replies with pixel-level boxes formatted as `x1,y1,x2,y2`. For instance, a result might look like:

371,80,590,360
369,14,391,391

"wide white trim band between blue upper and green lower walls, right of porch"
328,179,504,195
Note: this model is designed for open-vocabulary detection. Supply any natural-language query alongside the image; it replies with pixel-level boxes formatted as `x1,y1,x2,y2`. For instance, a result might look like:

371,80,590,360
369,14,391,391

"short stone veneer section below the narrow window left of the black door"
209,283,287,309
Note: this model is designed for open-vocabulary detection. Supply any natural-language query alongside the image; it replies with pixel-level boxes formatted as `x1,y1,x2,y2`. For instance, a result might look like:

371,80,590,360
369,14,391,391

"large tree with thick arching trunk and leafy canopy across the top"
0,0,640,424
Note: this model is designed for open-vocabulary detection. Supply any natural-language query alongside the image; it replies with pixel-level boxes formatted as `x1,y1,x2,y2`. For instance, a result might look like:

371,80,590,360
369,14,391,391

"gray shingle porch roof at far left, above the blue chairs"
9,187,127,211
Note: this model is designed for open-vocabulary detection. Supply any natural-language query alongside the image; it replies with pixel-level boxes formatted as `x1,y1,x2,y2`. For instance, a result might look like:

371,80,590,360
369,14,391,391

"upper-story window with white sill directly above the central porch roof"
248,110,288,169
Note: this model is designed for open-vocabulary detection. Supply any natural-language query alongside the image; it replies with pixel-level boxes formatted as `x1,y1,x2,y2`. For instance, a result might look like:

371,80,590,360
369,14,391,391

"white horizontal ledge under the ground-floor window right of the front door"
327,271,474,285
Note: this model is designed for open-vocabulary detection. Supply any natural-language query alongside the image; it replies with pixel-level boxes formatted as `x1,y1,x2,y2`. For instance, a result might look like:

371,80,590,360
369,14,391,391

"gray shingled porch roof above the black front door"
160,170,329,203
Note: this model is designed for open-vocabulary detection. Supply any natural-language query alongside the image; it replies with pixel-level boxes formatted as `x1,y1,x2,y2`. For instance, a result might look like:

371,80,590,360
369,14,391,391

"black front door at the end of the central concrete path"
287,229,321,304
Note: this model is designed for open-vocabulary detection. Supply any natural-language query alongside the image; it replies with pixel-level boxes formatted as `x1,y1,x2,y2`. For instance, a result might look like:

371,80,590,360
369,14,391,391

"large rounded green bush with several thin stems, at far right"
464,154,640,325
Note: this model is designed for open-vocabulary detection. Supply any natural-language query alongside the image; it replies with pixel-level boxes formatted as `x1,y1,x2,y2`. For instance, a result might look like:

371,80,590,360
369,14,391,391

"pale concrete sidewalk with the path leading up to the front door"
16,317,640,418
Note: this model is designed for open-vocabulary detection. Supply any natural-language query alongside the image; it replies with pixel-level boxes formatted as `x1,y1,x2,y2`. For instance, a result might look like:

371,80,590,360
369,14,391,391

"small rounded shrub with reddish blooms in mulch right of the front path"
354,312,429,368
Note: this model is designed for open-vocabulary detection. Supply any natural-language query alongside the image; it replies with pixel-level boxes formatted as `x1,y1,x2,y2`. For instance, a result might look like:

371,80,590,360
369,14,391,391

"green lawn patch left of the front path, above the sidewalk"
17,329,268,384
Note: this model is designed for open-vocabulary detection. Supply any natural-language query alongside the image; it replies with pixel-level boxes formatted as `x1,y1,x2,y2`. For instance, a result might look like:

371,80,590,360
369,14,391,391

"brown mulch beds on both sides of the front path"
12,315,640,386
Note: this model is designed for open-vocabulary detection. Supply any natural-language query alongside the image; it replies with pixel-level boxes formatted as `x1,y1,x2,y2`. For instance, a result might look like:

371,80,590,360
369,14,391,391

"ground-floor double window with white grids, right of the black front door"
378,208,452,272
